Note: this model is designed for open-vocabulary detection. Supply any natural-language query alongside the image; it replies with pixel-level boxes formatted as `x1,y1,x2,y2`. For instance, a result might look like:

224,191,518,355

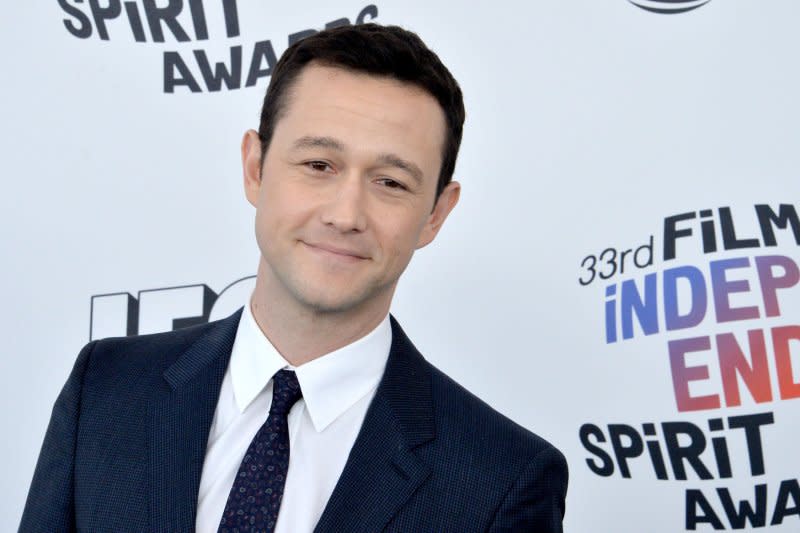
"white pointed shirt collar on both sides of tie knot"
230,299,392,432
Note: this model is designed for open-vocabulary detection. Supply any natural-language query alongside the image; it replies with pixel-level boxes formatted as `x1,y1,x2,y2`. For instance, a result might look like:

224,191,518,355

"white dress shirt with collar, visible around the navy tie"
196,302,392,533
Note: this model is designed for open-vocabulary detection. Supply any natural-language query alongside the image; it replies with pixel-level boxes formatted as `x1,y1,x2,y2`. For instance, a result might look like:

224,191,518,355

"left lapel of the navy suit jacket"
150,311,241,531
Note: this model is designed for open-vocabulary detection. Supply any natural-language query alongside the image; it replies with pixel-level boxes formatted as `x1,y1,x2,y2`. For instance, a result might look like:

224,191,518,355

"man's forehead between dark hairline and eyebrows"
275,63,446,181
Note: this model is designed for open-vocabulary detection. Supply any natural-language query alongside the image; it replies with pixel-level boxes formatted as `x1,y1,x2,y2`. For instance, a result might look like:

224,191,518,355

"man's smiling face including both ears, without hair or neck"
242,63,459,313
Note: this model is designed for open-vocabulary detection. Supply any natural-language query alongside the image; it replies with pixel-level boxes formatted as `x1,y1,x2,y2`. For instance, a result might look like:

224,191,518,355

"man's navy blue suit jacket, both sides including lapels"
20,312,567,533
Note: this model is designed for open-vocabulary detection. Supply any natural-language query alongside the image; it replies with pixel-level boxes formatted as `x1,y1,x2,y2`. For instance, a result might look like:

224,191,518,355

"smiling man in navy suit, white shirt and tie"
20,24,567,533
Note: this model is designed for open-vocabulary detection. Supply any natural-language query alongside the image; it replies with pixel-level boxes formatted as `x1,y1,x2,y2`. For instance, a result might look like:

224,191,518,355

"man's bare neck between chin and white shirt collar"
250,259,394,366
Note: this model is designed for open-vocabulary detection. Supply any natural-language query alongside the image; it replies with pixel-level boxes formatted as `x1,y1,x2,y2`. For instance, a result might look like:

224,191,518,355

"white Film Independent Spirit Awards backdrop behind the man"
0,0,800,533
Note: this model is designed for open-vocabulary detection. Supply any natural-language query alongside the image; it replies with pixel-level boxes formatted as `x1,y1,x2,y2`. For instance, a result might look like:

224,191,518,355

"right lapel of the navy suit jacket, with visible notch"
314,317,434,533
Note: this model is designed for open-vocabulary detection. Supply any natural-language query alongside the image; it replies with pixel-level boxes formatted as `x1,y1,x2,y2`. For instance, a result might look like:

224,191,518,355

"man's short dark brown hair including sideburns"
258,23,465,198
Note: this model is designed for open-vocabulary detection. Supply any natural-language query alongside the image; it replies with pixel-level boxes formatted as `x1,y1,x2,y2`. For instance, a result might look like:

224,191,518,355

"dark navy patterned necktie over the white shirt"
219,370,302,533
